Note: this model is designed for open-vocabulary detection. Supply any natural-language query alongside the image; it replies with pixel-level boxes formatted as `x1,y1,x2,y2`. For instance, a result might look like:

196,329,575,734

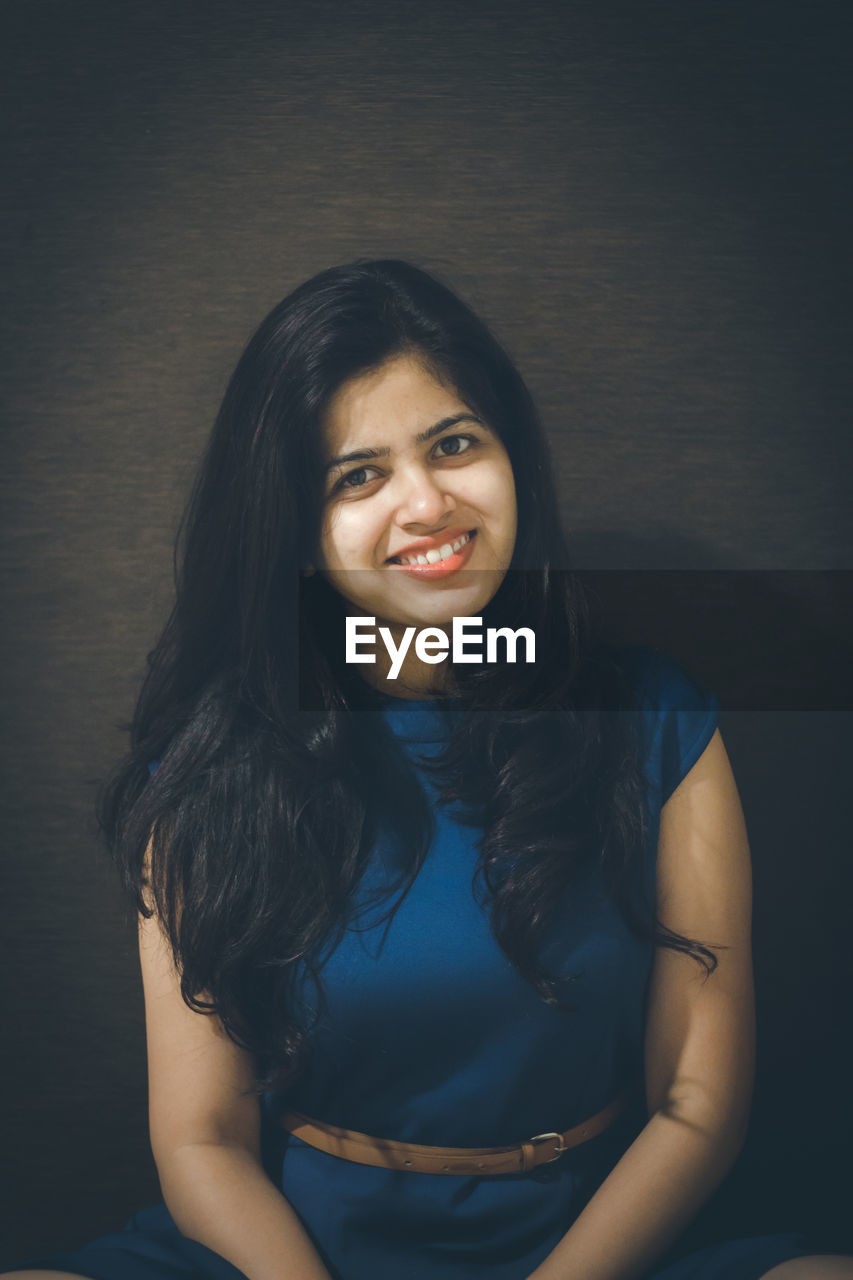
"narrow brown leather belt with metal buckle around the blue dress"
280,1089,637,1175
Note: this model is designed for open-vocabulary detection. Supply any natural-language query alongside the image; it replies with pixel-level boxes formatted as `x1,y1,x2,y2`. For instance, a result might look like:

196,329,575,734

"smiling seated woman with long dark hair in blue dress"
6,261,853,1280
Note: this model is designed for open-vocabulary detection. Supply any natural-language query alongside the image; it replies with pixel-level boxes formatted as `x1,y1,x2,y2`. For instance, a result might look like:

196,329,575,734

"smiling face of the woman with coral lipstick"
316,356,516,627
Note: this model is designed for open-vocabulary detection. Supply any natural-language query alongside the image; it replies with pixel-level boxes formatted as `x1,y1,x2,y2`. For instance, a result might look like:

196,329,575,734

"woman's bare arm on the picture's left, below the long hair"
140,915,329,1280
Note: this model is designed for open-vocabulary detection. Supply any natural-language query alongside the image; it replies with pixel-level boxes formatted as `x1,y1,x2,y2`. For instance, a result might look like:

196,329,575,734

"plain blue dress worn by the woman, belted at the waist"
13,649,809,1280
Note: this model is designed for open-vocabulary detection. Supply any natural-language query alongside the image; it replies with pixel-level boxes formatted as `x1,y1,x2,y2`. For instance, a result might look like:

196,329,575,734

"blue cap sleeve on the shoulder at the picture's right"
625,649,720,808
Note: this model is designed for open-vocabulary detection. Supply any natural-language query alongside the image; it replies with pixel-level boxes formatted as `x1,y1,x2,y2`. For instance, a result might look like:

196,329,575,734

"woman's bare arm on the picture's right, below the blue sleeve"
530,730,754,1280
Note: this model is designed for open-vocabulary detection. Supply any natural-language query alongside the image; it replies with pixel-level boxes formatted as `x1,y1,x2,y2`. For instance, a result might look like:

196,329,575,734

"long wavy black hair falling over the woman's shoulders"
100,260,715,1091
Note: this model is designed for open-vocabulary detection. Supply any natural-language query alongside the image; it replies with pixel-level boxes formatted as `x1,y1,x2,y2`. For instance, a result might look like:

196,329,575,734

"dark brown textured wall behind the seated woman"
0,0,853,1262
